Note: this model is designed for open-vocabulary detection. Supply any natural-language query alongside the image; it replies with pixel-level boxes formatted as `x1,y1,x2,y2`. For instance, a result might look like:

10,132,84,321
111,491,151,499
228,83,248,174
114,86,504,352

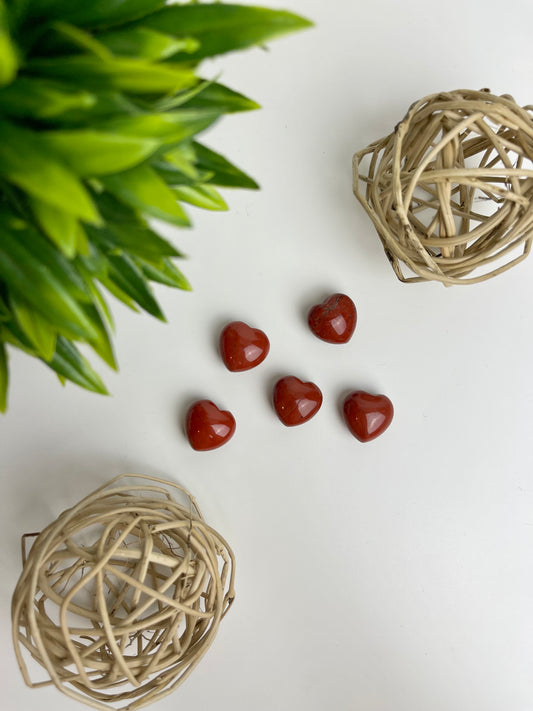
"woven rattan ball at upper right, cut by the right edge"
353,89,533,286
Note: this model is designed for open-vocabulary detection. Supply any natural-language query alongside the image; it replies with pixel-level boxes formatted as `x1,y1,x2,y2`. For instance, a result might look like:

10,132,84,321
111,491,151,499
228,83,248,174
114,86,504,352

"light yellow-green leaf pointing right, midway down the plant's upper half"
94,109,220,145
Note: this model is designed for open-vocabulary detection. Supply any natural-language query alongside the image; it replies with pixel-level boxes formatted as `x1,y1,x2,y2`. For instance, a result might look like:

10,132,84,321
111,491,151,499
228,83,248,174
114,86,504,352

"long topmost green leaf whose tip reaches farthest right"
138,2,312,60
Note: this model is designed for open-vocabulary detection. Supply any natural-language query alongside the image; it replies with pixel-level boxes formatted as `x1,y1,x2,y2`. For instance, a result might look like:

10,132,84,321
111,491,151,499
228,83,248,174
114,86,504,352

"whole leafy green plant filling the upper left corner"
0,0,310,411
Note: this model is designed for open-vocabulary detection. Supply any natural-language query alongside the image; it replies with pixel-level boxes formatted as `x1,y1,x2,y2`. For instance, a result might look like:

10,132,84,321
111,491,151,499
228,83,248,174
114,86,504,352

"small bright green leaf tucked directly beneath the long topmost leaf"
98,27,198,61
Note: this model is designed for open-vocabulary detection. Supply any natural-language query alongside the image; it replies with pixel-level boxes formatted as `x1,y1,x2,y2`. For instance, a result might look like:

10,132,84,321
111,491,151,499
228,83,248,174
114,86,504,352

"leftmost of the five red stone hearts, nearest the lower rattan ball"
185,400,235,452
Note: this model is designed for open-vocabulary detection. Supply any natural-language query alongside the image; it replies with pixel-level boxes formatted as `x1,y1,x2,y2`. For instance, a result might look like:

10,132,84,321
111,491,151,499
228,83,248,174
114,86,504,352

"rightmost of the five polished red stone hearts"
343,390,394,442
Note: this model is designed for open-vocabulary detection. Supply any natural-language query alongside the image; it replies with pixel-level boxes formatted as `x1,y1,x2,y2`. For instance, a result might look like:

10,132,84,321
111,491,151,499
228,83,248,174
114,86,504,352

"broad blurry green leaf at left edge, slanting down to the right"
0,121,98,223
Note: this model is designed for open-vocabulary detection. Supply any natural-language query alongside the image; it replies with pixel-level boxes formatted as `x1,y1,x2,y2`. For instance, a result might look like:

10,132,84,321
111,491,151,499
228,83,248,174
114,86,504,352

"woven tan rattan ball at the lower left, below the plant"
12,475,234,711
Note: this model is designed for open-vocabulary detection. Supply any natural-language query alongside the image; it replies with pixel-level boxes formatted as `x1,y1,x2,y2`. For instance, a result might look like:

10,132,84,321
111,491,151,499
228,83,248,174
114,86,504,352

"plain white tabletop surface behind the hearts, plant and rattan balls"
0,0,533,711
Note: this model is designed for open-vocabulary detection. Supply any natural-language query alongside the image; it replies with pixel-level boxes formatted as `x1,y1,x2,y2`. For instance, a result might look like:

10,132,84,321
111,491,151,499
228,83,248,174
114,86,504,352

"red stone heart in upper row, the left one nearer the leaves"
220,321,270,372
